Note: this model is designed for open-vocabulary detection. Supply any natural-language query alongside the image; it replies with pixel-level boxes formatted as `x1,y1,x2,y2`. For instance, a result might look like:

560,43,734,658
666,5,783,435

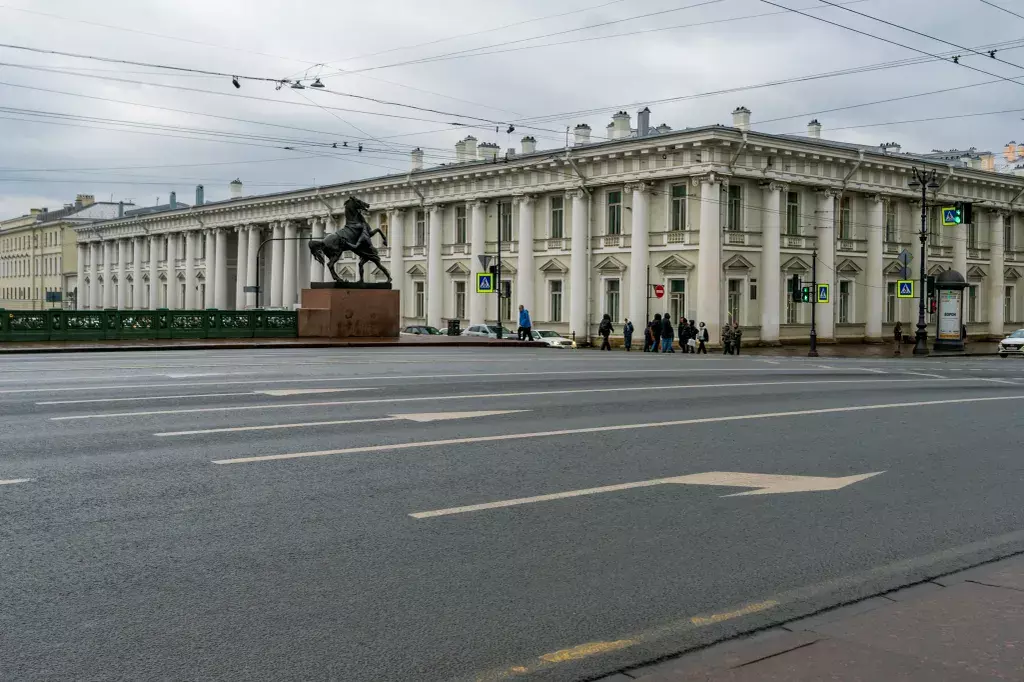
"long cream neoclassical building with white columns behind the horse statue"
76,108,1024,342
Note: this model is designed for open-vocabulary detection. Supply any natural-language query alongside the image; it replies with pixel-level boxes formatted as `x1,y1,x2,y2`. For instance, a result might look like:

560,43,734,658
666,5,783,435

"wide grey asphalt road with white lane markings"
0,349,1024,682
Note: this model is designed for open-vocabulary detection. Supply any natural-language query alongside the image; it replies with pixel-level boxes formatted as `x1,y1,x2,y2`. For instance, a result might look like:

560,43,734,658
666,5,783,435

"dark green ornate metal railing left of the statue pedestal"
0,308,298,342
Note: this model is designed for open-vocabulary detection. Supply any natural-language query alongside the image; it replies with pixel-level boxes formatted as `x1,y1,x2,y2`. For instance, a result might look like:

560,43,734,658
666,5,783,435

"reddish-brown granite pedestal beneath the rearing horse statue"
298,282,401,339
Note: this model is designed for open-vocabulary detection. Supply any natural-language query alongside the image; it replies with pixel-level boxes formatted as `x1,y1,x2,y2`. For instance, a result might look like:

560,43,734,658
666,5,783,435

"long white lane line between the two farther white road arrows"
50,379,977,422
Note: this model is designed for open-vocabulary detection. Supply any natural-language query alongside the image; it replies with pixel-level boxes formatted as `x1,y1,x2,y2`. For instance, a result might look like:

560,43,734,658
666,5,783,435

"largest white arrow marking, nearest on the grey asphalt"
410,471,884,518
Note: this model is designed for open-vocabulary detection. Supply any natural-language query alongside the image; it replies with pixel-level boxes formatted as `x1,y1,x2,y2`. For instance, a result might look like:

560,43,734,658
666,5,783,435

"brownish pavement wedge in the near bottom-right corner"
601,554,1024,682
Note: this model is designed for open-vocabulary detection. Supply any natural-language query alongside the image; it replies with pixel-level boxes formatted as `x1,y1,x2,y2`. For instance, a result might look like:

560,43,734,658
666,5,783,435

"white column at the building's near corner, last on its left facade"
697,173,722,343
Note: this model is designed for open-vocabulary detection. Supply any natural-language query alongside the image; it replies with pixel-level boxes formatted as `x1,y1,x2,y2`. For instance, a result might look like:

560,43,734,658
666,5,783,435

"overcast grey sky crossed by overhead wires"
0,0,1024,218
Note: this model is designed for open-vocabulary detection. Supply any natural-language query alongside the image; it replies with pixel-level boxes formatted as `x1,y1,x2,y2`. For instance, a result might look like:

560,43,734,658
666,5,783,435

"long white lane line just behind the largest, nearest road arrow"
213,395,1024,464
